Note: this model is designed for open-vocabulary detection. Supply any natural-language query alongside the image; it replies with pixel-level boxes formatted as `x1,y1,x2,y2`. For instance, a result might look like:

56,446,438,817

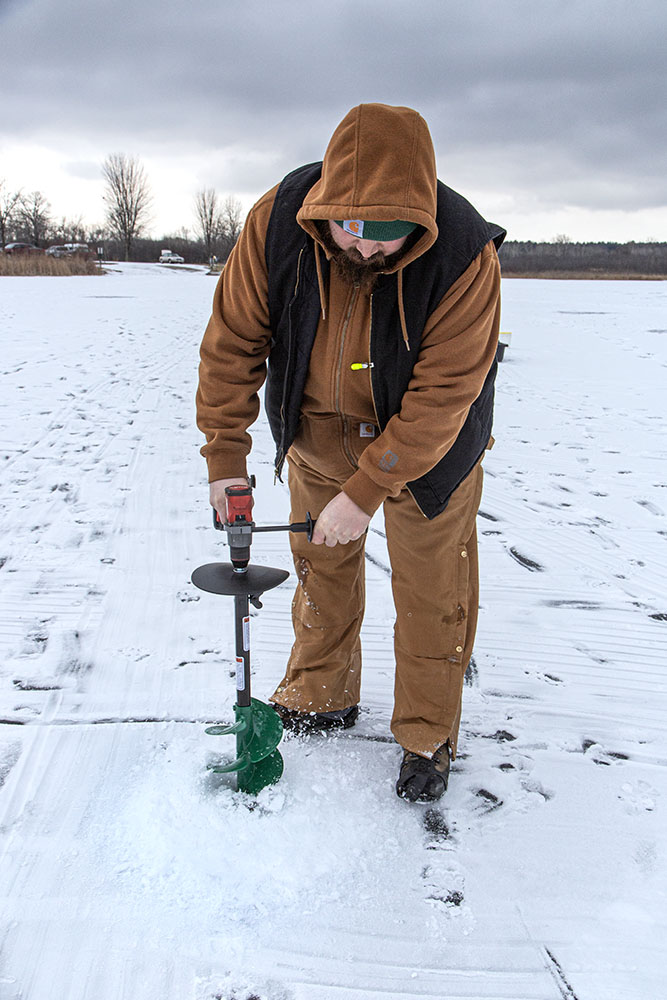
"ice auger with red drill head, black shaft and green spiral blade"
192,477,315,795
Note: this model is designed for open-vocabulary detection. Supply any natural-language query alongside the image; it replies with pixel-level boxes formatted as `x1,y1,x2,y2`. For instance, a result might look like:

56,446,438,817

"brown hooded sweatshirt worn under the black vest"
197,105,500,514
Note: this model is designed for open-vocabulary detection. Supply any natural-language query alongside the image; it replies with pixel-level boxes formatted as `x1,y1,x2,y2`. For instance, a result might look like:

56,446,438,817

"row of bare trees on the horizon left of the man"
0,153,243,263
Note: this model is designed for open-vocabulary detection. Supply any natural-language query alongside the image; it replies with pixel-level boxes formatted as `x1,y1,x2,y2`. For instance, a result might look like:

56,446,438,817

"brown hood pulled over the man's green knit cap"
297,104,438,270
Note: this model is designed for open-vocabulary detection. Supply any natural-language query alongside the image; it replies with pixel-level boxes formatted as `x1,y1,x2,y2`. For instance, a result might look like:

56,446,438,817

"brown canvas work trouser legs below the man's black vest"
271,448,482,756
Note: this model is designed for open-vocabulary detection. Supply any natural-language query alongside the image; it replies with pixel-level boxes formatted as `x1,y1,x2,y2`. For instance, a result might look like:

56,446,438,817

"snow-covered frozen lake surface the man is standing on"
0,265,667,1000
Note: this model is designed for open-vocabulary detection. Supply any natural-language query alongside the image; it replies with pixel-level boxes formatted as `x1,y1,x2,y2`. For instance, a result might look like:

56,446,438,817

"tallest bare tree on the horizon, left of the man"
102,153,151,260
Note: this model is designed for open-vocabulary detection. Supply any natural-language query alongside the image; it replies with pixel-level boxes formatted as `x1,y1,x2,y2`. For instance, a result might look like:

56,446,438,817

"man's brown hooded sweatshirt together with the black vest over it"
197,105,504,517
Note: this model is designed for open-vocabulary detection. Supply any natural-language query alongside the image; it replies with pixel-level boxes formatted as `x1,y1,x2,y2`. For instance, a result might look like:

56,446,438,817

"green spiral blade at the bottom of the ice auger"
206,698,283,794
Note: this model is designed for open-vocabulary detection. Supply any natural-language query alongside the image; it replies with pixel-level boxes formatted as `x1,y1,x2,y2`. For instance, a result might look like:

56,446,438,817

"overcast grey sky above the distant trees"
0,0,667,240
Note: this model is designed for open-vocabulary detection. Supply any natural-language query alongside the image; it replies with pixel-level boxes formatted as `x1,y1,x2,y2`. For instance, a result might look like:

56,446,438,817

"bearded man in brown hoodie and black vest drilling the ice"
197,104,505,801
